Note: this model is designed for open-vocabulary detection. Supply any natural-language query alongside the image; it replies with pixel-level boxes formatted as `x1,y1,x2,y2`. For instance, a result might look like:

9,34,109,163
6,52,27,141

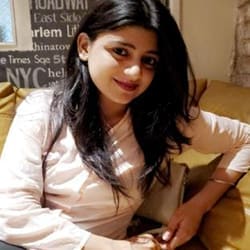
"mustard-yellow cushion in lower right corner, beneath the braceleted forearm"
199,173,250,250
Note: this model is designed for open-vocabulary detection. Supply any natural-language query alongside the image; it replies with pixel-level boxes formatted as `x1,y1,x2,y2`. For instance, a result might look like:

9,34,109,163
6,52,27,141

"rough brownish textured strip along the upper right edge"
231,0,250,87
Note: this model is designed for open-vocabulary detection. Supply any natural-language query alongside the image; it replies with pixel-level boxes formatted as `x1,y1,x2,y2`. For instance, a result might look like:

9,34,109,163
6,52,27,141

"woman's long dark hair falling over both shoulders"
44,0,198,207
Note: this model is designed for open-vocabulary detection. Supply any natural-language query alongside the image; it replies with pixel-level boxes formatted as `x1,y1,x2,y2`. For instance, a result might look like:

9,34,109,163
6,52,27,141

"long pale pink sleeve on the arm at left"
0,92,90,250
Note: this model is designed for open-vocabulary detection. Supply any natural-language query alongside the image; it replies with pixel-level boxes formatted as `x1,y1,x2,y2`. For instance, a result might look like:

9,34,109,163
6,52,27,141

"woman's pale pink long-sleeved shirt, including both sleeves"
0,90,250,250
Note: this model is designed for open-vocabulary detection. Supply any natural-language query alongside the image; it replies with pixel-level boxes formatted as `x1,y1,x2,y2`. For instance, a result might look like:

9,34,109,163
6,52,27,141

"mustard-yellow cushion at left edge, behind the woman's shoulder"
0,82,15,154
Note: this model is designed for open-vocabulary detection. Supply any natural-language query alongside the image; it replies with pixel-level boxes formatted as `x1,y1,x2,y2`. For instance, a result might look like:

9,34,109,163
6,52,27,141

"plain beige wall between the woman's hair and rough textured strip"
180,0,236,81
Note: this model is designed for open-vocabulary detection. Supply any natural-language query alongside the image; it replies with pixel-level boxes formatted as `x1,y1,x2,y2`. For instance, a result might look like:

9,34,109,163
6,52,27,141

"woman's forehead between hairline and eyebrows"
94,26,157,50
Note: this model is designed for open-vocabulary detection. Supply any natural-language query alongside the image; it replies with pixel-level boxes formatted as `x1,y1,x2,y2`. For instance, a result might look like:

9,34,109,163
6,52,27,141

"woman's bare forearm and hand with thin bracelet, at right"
162,168,242,250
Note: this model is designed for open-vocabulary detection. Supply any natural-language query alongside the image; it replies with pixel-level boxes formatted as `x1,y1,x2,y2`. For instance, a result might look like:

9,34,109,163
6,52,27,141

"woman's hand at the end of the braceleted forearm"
162,200,205,250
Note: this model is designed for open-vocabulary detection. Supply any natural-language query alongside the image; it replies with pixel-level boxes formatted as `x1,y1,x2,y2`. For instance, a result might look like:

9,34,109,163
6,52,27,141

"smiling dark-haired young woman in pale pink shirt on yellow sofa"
0,0,250,250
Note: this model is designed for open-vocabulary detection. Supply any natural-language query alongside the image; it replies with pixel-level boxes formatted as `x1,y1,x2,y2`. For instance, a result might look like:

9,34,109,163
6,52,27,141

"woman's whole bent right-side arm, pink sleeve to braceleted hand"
163,111,250,249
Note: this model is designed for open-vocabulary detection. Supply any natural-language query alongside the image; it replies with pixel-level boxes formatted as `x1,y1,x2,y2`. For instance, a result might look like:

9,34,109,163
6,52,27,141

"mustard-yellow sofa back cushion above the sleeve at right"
200,81,250,123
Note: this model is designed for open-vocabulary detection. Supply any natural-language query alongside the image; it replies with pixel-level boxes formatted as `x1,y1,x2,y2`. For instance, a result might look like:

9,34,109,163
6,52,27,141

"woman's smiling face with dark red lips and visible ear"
78,26,159,112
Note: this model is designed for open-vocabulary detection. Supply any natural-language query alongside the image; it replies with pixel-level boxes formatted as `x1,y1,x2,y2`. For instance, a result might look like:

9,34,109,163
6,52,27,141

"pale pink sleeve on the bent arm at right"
183,110,250,172
